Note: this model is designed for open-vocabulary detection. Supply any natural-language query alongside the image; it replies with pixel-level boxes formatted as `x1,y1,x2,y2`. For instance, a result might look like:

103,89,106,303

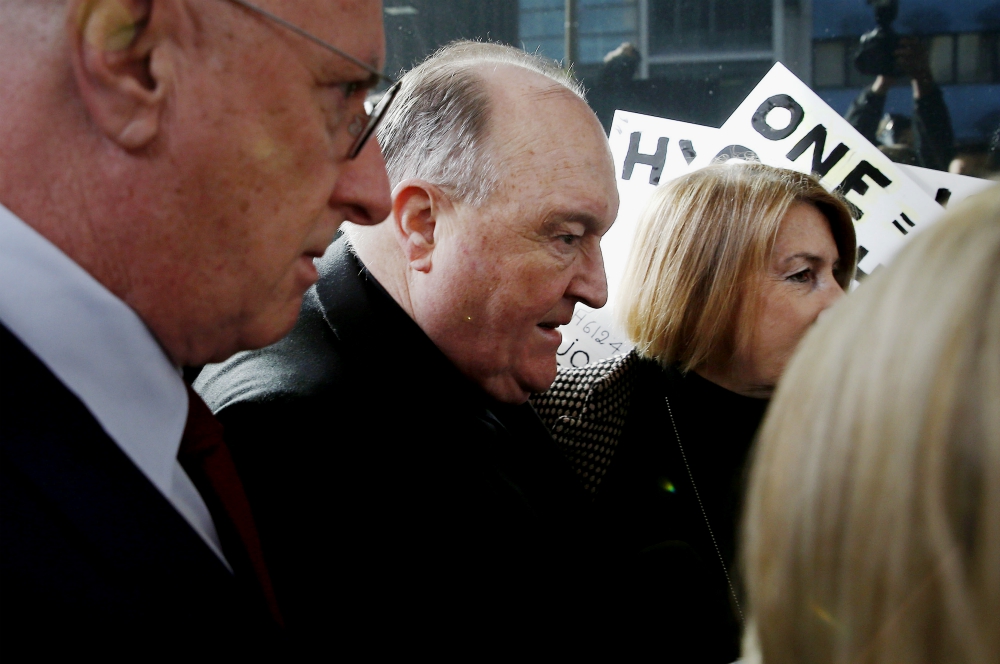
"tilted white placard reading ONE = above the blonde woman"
692,62,944,275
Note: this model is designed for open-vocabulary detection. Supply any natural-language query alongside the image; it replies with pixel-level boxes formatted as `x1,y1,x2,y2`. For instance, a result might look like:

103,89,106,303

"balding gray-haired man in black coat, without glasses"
196,42,618,640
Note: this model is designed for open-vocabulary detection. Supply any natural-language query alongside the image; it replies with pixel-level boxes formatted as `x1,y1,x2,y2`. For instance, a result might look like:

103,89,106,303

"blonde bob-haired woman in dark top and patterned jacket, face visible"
535,164,856,662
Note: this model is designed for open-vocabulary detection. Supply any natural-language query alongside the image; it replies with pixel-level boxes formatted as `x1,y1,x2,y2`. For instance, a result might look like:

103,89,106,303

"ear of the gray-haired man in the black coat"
392,179,450,272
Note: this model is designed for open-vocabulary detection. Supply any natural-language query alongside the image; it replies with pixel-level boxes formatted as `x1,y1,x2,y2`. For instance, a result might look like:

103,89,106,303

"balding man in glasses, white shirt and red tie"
0,0,390,648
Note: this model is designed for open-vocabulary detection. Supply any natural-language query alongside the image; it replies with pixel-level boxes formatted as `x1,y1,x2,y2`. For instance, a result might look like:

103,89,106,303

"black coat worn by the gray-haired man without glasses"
196,239,595,647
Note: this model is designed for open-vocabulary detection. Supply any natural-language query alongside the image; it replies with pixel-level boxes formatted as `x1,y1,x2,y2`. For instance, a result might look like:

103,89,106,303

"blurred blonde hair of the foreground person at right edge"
743,187,1000,664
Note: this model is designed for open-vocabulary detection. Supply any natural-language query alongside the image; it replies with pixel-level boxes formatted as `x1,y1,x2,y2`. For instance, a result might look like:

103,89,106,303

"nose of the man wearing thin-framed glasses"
330,136,392,225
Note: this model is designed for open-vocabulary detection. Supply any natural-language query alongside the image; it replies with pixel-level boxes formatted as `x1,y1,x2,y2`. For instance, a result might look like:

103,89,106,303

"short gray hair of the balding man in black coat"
378,41,586,206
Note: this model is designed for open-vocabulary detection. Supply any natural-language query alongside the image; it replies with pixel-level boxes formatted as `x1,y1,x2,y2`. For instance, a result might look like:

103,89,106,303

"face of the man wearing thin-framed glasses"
160,0,390,357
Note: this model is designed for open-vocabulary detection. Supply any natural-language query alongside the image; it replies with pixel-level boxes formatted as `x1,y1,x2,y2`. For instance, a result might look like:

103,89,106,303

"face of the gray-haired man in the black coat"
418,70,618,403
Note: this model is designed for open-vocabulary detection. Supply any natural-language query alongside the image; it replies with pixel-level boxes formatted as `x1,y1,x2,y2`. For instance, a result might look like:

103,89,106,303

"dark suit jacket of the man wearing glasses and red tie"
0,326,276,659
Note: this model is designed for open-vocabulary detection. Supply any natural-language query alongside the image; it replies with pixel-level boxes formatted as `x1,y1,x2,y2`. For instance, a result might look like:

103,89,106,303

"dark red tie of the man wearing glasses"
177,386,284,626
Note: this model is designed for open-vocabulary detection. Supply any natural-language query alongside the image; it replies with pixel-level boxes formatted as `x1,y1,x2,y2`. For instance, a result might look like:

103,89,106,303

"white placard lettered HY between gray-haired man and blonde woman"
557,111,720,366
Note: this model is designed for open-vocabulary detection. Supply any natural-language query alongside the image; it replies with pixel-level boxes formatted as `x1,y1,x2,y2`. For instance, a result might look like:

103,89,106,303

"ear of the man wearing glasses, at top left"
66,0,168,150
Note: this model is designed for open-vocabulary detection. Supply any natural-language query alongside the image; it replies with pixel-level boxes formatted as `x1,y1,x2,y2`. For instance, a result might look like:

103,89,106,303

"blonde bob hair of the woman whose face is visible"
620,163,857,371
